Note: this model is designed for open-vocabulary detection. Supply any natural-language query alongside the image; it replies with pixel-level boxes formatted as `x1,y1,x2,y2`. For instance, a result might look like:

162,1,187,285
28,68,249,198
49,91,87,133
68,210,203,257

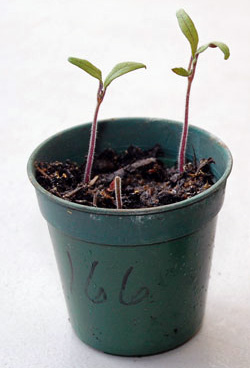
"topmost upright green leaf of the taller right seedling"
176,9,199,57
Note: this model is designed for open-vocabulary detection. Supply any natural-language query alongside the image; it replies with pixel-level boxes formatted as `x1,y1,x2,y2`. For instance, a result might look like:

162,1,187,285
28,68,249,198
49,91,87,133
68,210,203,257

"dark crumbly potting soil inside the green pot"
35,145,214,209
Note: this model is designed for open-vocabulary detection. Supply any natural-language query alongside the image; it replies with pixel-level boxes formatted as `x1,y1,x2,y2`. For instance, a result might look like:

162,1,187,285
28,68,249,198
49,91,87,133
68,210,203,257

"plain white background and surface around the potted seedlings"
0,0,250,368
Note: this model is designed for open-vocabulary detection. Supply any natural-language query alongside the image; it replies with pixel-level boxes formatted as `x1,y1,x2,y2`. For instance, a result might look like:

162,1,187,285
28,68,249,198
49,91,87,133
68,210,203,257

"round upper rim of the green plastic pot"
27,117,233,216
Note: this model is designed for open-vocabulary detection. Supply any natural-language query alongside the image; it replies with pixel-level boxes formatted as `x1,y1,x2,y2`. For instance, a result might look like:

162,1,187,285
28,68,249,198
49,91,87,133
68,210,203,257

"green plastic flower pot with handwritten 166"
28,118,232,356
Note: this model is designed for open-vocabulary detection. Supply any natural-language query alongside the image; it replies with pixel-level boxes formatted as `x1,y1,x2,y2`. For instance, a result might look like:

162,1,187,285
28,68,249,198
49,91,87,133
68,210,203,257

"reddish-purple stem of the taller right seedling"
178,55,198,173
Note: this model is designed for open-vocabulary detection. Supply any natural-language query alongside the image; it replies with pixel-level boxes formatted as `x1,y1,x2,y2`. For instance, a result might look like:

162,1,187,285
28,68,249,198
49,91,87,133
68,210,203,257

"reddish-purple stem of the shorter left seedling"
84,82,106,184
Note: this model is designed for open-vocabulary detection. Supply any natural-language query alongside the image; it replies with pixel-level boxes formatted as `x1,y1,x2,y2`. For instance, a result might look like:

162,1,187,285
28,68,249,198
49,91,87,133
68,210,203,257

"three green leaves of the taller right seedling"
172,9,230,77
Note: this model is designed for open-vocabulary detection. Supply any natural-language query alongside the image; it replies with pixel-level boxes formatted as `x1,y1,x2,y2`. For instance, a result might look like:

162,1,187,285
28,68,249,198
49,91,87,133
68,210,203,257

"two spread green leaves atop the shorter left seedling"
68,57,146,89
